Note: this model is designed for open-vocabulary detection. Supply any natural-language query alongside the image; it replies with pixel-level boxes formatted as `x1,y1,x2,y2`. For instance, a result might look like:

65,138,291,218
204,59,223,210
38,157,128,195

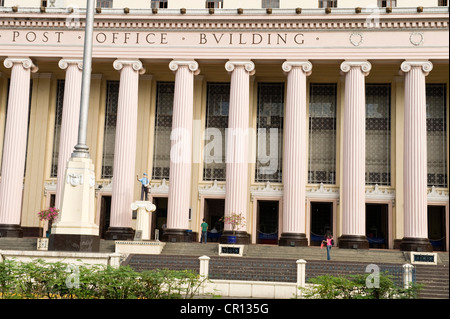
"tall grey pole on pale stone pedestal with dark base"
48,0,100,252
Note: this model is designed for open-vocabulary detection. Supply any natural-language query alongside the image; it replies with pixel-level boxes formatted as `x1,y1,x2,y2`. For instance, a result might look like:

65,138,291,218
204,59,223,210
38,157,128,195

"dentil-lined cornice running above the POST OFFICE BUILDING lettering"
0,12,449,31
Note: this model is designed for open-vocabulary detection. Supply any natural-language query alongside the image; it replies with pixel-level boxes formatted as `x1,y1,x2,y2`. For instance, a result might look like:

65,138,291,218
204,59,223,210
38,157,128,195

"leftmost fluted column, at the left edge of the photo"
0,58,38,237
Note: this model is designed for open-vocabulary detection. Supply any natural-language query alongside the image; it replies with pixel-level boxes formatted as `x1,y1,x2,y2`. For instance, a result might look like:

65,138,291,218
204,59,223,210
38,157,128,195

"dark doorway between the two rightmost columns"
366,204,388,249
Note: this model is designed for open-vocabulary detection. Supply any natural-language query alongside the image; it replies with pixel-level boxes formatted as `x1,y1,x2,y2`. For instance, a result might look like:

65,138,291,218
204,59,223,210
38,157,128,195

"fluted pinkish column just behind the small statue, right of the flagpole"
105,60,145,239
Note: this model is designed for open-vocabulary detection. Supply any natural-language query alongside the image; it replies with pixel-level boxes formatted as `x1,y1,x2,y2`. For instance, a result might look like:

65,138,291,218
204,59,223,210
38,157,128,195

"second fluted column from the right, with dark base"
339,61,371,249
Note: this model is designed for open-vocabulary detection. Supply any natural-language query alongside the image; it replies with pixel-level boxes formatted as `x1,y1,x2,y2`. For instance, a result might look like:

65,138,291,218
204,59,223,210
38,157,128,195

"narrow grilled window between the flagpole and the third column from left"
102,81,120,179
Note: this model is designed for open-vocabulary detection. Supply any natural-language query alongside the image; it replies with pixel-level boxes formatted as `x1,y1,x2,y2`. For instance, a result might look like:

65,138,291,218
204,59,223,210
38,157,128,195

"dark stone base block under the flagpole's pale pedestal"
48,234,100,252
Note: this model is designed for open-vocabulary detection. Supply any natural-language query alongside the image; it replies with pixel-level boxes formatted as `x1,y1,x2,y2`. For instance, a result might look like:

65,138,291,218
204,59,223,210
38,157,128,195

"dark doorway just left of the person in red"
310,202,333,246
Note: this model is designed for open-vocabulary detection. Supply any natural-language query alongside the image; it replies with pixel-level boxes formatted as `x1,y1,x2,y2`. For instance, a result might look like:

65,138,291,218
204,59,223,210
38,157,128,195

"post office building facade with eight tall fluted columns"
0,0,449,251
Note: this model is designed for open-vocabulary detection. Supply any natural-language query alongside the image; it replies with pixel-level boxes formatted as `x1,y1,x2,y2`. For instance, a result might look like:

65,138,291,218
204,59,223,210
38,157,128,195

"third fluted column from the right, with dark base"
279,61,312,246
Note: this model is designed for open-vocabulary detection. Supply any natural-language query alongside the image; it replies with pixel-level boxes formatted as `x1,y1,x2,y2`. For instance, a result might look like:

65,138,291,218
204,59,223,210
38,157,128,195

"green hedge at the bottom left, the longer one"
0,259,204,299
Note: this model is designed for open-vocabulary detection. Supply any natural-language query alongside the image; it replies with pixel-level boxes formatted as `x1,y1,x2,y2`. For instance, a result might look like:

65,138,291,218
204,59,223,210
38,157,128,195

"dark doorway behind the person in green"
203,198,225,242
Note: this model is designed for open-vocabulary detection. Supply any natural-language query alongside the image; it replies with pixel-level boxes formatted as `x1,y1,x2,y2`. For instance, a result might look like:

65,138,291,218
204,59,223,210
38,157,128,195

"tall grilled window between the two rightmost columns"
366,84,391,186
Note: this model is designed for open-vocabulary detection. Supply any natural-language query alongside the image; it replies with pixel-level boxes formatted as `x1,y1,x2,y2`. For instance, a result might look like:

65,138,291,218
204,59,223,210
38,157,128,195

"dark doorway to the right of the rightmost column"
428,205,446,251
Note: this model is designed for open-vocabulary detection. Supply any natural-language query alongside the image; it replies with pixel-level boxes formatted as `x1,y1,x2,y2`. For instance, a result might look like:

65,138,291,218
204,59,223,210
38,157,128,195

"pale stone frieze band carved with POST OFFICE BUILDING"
0,26,448,49
